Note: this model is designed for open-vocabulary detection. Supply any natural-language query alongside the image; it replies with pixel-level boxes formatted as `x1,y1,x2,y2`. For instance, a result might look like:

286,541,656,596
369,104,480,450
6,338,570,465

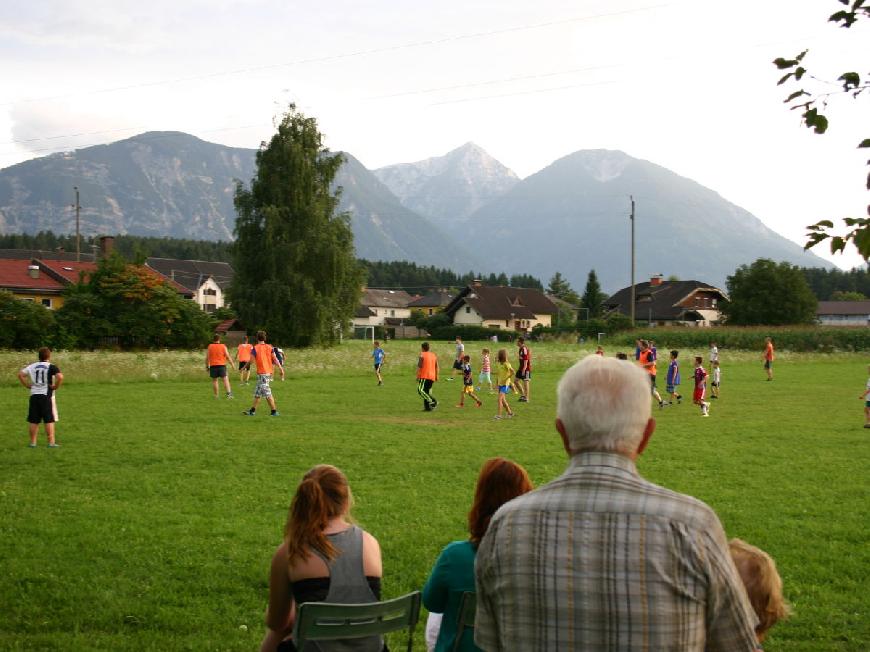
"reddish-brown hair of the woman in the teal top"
468,457,534,547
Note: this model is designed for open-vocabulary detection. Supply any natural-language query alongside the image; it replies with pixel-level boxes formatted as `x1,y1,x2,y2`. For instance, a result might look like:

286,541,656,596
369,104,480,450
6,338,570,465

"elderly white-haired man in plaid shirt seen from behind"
474,355,757,652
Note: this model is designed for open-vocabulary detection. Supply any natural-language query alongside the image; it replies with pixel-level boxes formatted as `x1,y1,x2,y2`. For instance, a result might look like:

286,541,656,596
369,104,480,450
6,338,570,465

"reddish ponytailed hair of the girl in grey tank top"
284,464,352,565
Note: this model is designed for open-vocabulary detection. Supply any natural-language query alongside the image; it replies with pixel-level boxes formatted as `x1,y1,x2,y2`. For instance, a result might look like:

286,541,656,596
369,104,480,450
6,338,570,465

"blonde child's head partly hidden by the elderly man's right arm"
728,539,791,643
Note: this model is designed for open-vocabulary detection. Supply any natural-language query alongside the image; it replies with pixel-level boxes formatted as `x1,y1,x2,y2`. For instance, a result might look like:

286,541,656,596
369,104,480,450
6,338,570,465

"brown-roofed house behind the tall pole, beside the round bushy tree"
603,276,728,326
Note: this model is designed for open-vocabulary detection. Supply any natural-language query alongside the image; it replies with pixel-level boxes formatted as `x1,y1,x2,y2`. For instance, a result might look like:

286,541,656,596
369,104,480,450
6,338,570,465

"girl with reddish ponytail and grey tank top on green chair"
260,464,384,652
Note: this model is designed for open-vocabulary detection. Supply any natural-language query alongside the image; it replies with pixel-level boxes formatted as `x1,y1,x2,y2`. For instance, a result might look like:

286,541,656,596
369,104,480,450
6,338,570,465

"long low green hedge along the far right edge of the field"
607,326,870,352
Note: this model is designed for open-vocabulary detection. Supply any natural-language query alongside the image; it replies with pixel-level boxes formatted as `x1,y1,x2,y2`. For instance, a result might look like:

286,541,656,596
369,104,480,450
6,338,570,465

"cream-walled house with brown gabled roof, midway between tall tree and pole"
444,281,559,332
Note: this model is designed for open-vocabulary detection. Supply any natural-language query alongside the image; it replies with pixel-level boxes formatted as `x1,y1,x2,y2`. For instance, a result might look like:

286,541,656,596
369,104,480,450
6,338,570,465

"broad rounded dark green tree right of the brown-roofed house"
723,258,818,326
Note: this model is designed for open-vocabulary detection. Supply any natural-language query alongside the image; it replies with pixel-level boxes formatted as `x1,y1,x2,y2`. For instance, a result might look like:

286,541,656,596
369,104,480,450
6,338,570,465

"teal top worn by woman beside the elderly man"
423,541,480,652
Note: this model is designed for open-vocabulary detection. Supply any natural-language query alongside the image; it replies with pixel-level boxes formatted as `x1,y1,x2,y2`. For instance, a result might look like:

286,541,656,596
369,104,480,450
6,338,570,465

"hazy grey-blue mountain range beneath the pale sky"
0,132,830,291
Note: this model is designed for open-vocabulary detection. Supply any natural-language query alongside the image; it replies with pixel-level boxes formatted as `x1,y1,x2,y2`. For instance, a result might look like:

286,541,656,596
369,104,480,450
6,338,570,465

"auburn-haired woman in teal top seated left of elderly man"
423,457,533,652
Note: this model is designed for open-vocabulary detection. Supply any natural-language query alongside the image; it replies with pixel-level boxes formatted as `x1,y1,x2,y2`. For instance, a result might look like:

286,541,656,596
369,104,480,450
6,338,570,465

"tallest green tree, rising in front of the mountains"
229,104,363,346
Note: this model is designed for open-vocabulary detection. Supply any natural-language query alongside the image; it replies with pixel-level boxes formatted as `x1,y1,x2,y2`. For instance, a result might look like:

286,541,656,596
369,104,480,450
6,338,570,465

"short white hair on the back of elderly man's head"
556,355,651,454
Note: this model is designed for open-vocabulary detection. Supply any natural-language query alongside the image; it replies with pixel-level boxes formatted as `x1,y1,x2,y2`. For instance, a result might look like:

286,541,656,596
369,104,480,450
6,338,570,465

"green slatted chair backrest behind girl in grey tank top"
293,591,420,652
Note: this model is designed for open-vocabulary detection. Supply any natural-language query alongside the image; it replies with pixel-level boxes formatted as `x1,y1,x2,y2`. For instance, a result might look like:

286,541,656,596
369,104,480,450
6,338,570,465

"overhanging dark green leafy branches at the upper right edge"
773,0,870,260
